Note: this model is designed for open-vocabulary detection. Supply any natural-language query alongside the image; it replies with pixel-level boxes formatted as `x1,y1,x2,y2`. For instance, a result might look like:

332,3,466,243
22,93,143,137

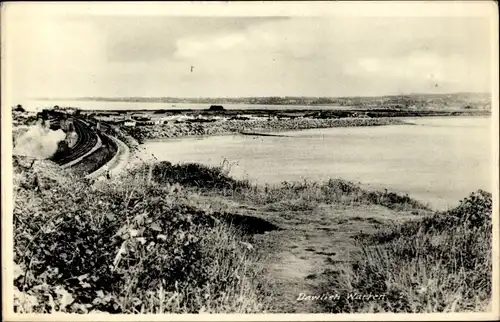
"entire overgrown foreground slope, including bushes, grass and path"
14,162,491,312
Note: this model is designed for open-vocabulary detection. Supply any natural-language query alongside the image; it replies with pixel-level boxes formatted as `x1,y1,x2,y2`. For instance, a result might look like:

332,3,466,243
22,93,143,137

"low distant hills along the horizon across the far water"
39,92,491,109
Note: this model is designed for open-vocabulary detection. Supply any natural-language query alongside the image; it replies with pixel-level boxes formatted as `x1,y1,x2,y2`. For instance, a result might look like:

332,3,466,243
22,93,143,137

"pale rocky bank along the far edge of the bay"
123,118,406,142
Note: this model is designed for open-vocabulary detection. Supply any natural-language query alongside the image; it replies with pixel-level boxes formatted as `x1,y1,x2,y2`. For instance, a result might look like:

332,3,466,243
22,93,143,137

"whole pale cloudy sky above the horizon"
4,1,492,102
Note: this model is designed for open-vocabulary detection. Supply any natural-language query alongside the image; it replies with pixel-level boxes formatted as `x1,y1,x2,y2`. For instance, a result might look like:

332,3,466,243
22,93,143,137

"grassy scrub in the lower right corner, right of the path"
323,190,492,313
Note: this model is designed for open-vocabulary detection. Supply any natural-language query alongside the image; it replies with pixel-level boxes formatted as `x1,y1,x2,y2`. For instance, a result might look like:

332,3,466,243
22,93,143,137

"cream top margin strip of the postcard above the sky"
4,1,496,17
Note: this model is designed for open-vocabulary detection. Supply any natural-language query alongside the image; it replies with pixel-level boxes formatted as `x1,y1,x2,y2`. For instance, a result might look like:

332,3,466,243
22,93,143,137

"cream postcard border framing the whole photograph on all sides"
1,1,500,321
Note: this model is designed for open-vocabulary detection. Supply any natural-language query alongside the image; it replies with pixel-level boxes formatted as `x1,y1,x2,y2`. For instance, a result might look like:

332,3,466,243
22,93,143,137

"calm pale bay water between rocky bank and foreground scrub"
144,117,492,209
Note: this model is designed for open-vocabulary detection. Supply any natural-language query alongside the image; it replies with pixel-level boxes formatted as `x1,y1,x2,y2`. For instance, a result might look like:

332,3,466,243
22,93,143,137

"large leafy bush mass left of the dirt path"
14,165,266,313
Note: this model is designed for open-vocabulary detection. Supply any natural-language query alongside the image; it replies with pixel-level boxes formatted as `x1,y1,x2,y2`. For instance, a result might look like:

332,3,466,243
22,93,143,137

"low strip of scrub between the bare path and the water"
134,160,430,212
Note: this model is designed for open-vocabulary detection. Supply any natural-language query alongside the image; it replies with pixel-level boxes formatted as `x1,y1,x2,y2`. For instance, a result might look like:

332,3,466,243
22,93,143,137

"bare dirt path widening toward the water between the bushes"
197,195,420,313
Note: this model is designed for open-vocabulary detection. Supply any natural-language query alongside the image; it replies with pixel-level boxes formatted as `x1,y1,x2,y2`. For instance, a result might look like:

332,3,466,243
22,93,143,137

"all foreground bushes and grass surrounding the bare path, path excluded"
14,160,491,313
